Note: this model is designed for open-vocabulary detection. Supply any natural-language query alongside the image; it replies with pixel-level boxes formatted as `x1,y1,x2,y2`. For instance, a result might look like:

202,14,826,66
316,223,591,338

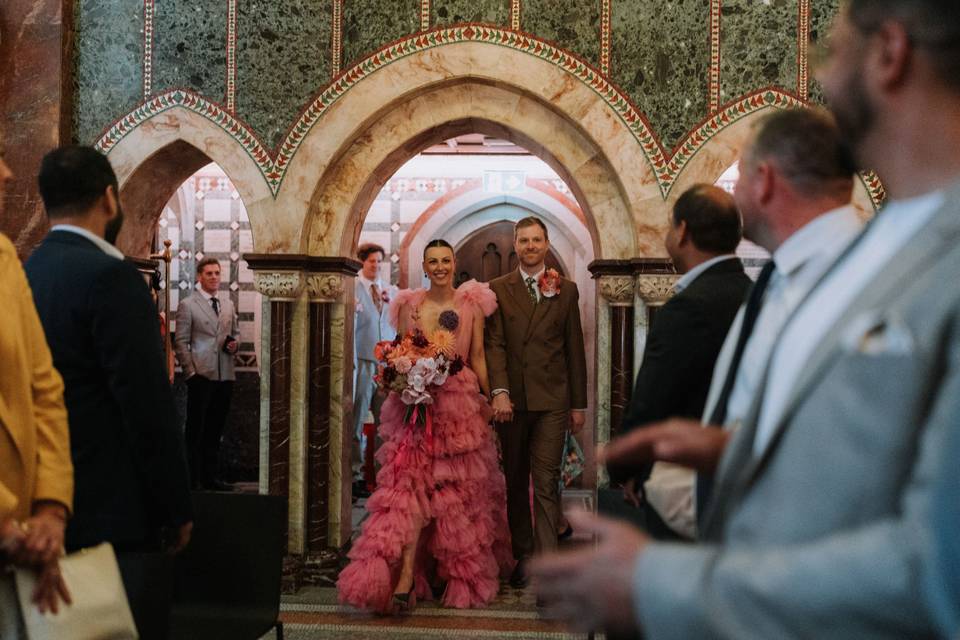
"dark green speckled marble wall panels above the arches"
74,0,838,150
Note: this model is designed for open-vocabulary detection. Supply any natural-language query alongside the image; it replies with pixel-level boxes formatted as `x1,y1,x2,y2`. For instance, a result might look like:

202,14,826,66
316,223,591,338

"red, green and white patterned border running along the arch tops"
97,25,876,206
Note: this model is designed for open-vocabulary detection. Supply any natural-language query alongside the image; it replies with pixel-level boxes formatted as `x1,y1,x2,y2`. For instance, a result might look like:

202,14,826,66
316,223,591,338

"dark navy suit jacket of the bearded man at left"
26,231,192,549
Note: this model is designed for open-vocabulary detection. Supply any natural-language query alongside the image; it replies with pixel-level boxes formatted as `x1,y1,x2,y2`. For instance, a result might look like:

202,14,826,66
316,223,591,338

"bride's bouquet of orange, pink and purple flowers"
374,312,464,425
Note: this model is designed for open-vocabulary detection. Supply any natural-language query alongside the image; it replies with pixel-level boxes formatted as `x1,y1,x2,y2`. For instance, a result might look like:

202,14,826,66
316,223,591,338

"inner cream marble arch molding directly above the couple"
300,86,632,257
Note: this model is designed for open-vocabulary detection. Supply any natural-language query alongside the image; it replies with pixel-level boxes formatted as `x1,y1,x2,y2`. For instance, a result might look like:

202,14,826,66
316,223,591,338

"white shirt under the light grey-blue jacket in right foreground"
753,191,944,456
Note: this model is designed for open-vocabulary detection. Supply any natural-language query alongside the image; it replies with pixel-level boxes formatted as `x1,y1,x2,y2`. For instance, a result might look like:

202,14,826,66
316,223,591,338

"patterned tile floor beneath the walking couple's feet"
264,490,602,640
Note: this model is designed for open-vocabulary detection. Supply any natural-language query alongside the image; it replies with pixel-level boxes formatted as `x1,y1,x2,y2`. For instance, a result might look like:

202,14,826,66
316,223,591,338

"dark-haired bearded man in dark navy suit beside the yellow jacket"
26,147,193,638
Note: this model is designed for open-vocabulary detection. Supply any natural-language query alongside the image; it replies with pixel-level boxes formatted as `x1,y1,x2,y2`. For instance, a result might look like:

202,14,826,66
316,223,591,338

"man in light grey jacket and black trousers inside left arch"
174,258,240,490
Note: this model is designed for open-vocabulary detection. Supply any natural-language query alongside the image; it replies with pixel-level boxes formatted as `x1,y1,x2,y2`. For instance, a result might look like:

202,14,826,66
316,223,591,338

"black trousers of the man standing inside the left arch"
184,374,233,488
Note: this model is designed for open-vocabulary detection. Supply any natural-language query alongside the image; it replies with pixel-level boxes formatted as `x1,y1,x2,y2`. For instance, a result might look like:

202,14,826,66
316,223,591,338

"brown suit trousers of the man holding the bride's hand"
497,410,570,559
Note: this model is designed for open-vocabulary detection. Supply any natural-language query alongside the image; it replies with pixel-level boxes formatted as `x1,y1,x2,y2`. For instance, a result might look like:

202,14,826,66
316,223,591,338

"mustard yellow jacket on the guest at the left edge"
0,234,73,521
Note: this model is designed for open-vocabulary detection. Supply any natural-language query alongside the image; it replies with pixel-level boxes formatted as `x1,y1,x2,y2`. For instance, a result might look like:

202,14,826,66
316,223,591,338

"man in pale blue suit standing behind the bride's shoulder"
353,243,397,497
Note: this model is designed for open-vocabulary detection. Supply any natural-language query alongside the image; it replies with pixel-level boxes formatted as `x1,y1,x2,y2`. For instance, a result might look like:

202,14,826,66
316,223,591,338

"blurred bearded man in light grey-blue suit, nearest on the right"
539,0,960,639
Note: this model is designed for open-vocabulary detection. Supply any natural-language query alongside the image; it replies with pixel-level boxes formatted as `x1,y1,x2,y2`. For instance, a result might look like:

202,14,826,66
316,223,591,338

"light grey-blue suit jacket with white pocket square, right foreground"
635,187,960,639
